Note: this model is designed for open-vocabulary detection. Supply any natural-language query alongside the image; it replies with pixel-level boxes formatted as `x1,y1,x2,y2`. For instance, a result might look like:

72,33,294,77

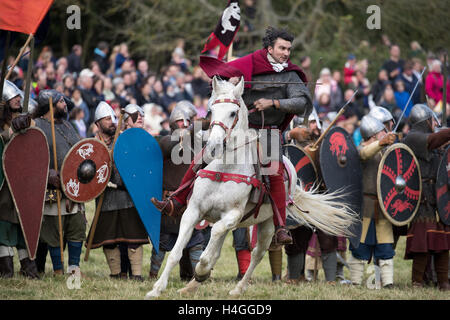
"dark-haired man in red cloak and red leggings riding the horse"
152,27,313,244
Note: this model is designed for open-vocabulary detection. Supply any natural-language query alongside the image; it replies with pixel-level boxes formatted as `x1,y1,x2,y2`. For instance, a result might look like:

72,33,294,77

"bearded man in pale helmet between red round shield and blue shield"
90,101,148,281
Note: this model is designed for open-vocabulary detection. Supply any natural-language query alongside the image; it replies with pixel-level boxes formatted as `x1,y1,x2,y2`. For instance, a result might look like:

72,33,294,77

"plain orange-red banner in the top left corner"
0,0,53,34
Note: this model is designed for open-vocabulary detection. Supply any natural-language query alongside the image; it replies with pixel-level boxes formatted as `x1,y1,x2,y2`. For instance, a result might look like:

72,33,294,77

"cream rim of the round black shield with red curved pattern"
377,142,422,227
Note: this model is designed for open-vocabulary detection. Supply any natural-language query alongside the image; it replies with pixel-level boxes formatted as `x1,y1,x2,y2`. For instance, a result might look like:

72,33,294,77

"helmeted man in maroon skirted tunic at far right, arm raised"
403,104,450,291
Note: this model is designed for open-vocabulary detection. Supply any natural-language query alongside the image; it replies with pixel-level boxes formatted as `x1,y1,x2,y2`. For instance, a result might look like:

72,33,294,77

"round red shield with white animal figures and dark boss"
60,138,111,203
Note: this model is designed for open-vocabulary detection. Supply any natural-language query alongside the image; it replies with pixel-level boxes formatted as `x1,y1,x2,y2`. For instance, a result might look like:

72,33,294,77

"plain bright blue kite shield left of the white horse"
114,128,163,252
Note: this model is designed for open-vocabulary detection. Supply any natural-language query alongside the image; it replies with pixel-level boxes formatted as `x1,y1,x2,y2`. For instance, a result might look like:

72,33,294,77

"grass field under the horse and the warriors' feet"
0,203,450,300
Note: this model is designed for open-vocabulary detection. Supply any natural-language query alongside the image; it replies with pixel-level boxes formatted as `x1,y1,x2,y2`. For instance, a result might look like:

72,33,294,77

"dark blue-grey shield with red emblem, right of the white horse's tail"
319,127,363,248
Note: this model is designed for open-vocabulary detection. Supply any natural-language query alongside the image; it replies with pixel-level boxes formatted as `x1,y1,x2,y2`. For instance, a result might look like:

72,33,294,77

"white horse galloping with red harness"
146,77,357,299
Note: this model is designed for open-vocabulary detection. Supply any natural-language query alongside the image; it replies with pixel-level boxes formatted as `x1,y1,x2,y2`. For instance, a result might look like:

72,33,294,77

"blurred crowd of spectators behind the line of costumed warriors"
4,33,450,144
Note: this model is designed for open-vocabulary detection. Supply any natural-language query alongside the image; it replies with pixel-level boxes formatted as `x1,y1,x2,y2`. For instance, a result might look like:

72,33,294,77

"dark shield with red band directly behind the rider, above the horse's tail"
283,144,318,191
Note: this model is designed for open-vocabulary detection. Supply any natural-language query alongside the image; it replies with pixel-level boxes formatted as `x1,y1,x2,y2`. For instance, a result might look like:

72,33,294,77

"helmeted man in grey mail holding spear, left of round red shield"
33,90,86,275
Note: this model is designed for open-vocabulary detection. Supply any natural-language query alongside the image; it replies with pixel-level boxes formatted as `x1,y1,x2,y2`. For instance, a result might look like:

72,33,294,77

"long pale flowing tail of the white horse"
287,185,359,237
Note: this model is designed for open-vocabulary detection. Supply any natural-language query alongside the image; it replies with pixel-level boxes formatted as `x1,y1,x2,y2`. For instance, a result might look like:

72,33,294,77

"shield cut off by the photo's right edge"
436,146,450,226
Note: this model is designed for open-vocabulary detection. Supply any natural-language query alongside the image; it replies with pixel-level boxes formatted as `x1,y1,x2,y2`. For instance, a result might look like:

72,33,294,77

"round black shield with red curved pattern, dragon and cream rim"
377,143,422,226
